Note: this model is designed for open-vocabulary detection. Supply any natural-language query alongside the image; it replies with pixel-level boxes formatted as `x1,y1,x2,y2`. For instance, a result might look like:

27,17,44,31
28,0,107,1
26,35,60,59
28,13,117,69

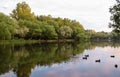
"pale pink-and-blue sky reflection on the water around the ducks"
31,46,120,77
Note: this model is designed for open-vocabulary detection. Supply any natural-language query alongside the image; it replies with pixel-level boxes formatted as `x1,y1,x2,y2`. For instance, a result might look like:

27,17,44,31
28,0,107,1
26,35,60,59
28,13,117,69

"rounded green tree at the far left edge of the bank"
0,13,17,40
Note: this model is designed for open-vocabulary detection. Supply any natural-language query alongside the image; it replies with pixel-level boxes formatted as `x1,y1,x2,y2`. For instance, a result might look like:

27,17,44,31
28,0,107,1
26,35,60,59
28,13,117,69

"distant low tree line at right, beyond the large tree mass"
86,30,120,41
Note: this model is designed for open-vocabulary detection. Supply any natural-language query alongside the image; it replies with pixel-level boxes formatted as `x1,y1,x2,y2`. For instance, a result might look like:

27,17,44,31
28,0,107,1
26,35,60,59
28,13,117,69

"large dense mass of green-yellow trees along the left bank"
0,2,88,40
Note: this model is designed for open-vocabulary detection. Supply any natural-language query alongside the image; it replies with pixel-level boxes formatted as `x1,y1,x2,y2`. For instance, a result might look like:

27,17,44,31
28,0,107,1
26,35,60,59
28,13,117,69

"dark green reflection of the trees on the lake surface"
0,42,120,77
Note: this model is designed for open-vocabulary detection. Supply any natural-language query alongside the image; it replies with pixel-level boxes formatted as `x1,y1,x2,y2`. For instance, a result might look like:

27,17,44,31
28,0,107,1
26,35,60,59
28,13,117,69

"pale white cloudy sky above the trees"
0,0,115,32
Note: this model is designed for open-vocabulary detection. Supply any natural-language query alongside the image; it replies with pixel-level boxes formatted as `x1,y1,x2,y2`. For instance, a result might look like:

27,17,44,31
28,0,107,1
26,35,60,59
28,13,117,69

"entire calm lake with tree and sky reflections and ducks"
0,42,120,77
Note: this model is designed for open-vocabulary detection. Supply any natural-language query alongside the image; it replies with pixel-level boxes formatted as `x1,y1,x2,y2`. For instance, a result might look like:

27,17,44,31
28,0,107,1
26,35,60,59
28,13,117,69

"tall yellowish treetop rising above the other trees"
10,2,35,20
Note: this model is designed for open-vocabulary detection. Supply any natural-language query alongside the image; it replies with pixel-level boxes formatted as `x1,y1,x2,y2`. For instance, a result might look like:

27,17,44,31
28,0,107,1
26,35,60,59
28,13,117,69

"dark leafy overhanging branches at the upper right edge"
109,0,120,34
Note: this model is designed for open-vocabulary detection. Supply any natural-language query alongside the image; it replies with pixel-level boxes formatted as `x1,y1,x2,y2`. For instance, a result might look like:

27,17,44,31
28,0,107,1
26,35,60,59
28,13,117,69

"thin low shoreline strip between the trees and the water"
0,39,120,45
